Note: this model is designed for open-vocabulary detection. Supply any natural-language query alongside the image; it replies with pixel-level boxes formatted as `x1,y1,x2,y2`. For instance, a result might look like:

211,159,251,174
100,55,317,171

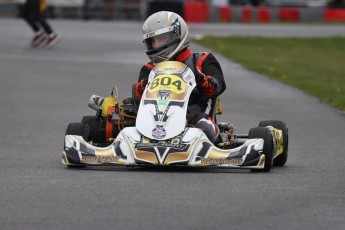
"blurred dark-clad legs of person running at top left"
22,0,60,48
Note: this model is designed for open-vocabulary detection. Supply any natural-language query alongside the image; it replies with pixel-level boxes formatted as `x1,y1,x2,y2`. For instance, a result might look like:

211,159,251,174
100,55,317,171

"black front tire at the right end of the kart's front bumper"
248,127,273,172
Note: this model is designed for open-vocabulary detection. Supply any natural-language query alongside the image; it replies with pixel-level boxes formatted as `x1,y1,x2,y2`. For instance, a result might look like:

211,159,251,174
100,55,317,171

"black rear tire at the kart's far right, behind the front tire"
259,120,289,167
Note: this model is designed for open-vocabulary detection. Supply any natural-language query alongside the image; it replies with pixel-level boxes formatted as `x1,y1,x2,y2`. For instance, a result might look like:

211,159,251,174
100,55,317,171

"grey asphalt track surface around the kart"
0,19,345,230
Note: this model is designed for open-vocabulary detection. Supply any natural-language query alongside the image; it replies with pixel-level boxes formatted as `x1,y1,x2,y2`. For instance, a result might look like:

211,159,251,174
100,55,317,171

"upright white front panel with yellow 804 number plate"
136,62,196,140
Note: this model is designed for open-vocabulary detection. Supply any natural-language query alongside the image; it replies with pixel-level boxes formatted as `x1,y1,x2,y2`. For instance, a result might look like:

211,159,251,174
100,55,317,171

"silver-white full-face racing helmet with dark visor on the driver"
143,11,190,64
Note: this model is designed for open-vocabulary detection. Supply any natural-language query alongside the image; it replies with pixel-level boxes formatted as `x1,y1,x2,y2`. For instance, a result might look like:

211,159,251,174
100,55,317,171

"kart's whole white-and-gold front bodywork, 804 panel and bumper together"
62,62,265,169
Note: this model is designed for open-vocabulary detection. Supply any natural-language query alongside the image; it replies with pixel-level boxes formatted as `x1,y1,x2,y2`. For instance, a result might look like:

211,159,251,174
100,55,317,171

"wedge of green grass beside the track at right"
195,37,345,112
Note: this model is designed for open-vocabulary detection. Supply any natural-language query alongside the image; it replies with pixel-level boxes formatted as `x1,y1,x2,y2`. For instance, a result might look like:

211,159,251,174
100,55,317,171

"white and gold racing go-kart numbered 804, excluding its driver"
62,61,288,172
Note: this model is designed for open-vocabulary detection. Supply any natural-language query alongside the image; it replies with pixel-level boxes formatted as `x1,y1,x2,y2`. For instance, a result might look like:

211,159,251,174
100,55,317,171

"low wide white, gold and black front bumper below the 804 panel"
62,127,265,168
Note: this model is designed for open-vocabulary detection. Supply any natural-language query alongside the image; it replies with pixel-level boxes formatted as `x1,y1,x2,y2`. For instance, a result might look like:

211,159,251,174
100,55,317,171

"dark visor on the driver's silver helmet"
143,26,181,55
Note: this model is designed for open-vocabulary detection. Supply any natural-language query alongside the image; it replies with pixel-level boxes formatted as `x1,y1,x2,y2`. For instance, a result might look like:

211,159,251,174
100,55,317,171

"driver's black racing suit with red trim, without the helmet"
135,48,226,142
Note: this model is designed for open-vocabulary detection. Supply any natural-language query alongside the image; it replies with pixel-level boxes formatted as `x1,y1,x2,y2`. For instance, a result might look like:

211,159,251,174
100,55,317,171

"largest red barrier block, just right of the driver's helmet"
184,2,209,22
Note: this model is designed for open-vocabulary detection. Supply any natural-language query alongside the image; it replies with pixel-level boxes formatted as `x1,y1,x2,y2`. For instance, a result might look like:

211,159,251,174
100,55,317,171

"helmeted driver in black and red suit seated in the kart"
135,11,226,142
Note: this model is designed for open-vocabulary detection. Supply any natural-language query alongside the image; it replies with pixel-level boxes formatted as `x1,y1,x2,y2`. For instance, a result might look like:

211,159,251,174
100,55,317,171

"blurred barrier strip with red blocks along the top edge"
0,0,345,23
